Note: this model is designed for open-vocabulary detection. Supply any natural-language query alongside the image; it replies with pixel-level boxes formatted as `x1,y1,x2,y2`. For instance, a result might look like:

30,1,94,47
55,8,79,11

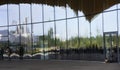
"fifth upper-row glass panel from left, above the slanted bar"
44,5,54,21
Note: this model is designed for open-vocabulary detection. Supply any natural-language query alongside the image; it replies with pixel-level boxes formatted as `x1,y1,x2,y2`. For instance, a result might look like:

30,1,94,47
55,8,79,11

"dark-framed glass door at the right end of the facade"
104,31,119,62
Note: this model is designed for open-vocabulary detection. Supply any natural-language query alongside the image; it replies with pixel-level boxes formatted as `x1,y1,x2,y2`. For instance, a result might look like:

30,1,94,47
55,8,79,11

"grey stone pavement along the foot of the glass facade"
0,60,120,70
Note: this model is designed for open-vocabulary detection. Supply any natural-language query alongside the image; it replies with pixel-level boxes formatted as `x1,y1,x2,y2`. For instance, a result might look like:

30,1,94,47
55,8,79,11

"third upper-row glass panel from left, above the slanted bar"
20,4,31,24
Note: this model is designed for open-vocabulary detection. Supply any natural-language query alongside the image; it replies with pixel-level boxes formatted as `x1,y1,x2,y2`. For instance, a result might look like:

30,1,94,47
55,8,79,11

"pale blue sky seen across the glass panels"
0,4,120,39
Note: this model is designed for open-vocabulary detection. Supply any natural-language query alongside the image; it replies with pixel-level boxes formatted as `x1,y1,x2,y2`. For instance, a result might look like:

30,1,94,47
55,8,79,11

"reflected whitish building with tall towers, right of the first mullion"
9,25,31,44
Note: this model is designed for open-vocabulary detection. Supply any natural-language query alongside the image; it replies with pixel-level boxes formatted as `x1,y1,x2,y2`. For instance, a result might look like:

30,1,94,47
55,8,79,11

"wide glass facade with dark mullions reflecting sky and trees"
0,4,120,61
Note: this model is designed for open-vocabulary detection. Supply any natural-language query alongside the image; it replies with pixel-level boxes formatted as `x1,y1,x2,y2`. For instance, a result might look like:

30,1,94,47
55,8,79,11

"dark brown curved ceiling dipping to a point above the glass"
0,0,120,22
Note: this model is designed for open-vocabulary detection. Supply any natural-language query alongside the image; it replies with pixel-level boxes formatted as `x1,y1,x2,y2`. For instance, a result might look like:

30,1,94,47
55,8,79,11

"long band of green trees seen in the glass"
37,28,103,48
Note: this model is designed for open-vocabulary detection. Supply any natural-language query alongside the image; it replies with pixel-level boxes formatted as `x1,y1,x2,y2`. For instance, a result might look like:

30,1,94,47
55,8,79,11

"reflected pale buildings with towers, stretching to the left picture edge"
0,22,31,45
